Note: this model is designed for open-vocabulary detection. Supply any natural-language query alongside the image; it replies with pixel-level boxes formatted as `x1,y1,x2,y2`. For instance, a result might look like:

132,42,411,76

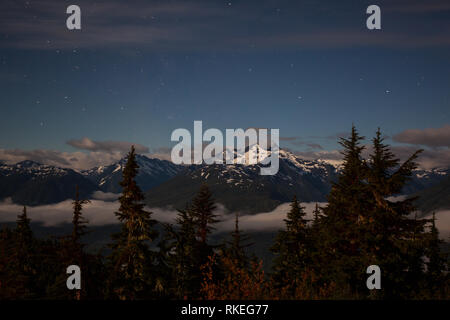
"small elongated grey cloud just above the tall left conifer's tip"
67,137,149,153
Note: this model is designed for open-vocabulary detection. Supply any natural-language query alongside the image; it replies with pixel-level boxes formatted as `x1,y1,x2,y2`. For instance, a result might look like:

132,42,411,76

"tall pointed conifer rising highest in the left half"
110,146,157,300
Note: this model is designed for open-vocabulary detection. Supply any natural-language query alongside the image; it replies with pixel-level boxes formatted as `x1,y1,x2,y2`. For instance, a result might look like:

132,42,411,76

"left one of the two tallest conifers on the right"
319,126,372,293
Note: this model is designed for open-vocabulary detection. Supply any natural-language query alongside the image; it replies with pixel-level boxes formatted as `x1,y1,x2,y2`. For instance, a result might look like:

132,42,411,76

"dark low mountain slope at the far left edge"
0,161,97,206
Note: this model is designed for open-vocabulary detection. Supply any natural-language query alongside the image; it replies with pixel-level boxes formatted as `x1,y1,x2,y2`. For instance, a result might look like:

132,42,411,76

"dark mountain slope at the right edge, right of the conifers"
415,177,450,214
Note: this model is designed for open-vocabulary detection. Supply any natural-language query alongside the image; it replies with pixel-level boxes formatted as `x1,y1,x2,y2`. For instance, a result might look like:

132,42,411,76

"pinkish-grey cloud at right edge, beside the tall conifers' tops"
392,124,450,147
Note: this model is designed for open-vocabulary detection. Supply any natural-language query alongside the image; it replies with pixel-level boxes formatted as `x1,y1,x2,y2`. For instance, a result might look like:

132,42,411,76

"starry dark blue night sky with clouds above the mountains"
0,0,450,168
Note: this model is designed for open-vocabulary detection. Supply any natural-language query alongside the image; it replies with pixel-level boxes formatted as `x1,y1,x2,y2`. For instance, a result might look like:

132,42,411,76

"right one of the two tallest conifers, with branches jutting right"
360,129,426,298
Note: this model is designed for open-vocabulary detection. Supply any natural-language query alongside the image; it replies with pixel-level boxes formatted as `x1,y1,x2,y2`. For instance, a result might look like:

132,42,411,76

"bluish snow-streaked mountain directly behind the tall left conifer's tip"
82,155,184,193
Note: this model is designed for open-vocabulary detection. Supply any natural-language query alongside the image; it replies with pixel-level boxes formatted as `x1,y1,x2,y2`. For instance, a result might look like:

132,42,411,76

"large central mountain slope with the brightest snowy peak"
146,150,336,213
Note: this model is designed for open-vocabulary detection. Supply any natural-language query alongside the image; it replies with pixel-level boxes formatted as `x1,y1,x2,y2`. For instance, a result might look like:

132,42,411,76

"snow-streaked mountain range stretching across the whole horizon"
0,146,450,213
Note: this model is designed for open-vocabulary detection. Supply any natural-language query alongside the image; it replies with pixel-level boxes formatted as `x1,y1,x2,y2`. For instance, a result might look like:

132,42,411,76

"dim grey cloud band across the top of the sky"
0,0,450,50
